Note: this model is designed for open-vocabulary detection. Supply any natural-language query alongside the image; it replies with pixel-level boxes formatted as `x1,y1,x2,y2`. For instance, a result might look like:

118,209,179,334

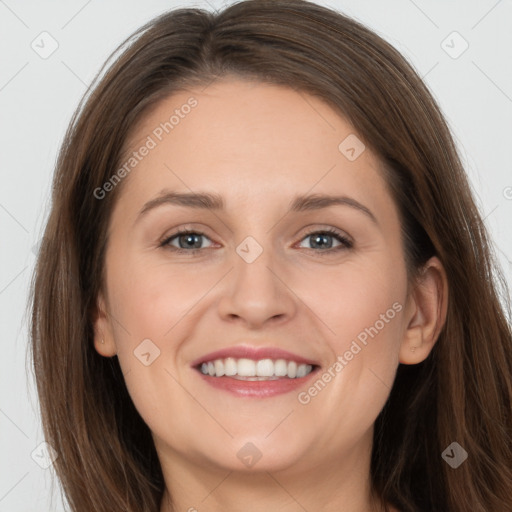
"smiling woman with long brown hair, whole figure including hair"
32,0,512,512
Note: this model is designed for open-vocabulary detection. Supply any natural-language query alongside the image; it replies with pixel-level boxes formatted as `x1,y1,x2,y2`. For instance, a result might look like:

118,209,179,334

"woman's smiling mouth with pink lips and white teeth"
193,347,320,398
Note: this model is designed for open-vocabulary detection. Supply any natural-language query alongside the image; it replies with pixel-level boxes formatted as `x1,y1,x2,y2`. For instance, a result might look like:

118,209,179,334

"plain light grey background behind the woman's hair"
0,0,512,512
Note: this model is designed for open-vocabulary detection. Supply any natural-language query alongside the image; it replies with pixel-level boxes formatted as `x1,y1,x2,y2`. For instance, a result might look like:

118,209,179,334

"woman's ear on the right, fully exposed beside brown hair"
399,256,448,364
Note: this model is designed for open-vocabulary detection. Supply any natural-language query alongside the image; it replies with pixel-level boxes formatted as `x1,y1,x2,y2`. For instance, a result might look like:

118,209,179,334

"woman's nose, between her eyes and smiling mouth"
218,243,298,329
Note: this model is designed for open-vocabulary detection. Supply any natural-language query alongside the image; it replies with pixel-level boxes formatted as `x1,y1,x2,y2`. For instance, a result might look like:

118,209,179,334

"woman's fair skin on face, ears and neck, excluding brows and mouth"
95,78,447,512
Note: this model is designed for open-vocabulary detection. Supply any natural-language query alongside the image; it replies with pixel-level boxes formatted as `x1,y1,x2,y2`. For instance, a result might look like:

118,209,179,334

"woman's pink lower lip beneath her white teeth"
197,368,318,398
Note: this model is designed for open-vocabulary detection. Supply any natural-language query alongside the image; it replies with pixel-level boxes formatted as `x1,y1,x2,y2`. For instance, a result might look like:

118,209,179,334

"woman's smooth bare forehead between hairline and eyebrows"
114,80,385,216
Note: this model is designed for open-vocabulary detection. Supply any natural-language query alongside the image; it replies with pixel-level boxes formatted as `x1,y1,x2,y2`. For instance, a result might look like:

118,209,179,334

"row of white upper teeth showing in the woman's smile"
201,357,313,379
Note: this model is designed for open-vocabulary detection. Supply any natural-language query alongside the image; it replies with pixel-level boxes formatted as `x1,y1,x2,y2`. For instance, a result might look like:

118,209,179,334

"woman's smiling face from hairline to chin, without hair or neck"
96,79,414,471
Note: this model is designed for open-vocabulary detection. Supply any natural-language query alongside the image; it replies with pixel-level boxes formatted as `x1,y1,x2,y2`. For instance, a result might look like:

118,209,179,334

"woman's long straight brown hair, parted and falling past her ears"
31,0,512,512
